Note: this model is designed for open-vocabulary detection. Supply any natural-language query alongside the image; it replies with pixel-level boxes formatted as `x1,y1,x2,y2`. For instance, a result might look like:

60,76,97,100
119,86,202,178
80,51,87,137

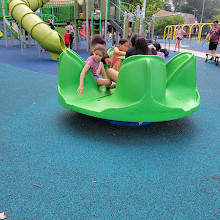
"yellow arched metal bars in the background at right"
163,23,213,44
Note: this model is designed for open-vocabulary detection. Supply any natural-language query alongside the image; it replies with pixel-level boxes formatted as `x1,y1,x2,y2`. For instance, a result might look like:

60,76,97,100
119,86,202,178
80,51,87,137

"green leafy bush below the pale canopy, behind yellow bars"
155,15,184,34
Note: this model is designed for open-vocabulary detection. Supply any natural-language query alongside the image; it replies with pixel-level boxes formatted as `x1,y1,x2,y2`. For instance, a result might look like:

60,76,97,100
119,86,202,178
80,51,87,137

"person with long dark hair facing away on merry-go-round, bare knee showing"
107,37,152,83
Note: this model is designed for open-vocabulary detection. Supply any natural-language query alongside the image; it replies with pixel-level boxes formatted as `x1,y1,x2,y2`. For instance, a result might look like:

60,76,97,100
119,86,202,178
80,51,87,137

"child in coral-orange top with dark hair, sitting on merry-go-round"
111,38,130,71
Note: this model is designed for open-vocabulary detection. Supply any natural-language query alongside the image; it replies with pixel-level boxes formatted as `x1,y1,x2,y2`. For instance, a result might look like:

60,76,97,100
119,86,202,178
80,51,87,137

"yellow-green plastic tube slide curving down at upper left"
8,0,66,60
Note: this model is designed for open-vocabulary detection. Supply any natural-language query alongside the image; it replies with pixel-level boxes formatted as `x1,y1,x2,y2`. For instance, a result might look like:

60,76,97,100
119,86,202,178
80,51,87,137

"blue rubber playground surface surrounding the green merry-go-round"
0,38,220,220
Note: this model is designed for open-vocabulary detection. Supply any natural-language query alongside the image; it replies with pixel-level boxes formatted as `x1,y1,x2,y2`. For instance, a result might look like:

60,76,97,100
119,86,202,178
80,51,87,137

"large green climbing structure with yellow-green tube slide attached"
1,0,149,60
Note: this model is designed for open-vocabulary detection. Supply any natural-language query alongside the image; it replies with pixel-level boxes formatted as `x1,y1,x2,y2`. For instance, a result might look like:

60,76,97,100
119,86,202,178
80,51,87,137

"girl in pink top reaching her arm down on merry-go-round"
77,44,112,94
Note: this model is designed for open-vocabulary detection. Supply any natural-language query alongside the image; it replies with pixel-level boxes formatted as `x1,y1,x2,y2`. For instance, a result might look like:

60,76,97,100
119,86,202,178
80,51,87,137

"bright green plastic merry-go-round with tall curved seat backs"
58,50,200,122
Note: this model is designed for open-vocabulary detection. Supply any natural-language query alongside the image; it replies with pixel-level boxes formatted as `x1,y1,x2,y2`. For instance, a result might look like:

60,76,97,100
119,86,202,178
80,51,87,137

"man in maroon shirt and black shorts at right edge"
205,21,220,60
